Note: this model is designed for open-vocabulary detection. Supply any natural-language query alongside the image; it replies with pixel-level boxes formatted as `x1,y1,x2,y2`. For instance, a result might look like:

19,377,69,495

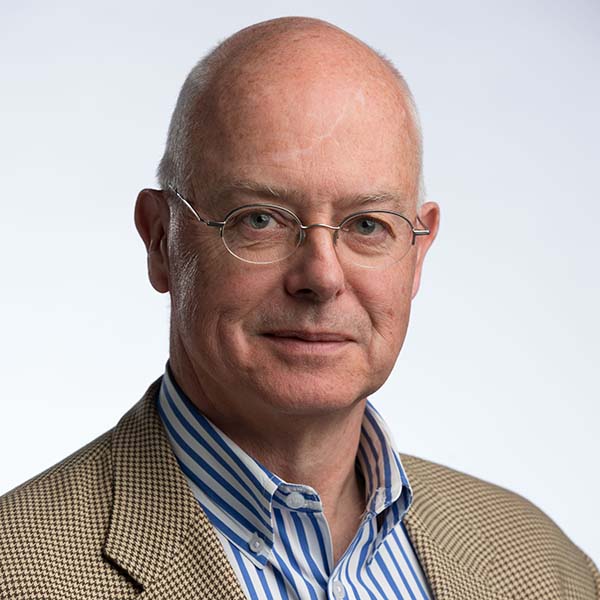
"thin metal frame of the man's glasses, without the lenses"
168,184,431,269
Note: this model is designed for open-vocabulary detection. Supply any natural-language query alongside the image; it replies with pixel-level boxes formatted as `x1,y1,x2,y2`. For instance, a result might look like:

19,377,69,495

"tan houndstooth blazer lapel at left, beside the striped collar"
103,379,245,600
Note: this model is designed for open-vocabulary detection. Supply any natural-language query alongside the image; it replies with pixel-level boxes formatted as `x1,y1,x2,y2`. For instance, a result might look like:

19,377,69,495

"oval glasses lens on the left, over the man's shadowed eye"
223,204,300,264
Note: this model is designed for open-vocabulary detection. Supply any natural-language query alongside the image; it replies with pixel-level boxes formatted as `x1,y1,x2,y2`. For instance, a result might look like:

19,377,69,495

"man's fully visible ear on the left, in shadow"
135,189,170,293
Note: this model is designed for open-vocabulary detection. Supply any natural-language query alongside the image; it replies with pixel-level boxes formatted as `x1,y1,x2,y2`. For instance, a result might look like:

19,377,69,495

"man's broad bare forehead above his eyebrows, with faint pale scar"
193,35,415,210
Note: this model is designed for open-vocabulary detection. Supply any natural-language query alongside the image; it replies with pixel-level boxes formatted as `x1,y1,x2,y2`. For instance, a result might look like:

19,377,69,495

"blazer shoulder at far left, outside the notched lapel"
0,431,135,600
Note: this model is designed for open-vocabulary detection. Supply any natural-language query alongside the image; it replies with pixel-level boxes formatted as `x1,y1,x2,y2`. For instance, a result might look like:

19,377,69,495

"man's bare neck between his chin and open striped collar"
170,352,366,562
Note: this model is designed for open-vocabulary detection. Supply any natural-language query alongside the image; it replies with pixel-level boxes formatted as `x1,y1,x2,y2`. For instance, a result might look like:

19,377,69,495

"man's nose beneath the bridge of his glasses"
285,225,346,302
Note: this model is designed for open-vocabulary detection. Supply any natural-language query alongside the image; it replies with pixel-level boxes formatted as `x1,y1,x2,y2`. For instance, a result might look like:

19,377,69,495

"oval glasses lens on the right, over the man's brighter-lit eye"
338,211,413,268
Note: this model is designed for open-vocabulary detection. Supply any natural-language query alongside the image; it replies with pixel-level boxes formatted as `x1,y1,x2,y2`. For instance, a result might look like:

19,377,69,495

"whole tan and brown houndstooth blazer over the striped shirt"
0,382,600,600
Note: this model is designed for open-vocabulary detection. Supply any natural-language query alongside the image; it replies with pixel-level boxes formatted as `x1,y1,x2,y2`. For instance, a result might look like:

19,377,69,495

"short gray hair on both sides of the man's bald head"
157,42,425,207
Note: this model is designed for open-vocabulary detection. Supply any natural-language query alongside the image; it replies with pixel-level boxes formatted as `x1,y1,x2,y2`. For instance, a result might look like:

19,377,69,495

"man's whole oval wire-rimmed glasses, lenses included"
168,185,430,269
